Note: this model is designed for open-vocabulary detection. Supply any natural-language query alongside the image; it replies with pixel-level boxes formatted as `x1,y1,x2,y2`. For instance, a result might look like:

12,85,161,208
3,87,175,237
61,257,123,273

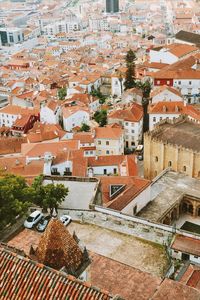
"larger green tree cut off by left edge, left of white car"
0,174,33,230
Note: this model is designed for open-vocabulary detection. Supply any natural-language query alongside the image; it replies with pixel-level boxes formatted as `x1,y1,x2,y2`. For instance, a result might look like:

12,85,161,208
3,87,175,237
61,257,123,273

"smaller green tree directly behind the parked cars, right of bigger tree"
32,175,69,214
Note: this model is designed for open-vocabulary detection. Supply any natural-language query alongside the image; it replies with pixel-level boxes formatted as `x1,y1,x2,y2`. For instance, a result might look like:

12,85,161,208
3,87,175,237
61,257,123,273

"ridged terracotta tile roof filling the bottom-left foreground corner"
0,247,113,300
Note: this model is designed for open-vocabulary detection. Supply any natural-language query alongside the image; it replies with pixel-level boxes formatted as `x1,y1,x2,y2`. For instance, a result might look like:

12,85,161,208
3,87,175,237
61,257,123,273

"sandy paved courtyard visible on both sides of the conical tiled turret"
8,222,167,276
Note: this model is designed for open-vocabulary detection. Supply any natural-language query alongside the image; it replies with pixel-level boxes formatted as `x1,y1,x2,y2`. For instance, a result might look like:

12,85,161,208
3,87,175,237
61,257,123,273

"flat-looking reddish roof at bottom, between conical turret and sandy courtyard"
90,253,162,300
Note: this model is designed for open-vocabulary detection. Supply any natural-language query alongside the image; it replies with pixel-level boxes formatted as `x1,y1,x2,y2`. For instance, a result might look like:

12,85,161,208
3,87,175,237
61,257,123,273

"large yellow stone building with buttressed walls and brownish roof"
144,120,200,180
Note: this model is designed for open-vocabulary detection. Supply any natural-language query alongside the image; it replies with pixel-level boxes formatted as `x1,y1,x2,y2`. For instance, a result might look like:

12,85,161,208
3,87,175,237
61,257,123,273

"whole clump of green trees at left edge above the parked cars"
0,174,68,230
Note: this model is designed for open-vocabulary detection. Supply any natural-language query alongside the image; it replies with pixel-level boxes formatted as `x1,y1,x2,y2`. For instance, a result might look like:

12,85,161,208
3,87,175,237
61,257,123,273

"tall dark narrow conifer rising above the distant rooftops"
124,49,136,90
